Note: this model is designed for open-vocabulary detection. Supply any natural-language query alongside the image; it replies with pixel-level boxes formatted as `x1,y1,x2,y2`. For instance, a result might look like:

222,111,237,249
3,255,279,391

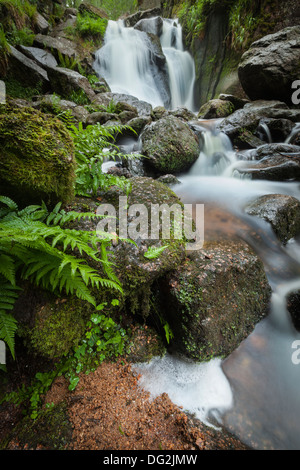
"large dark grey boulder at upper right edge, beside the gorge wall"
238,26,300,104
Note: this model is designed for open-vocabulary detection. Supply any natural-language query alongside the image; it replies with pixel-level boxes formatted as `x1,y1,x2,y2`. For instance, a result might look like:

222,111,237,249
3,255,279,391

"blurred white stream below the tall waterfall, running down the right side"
136,123,300,449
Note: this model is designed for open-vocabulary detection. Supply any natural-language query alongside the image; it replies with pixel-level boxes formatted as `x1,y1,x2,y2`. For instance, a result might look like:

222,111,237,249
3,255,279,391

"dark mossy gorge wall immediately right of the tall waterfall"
162,0,300,106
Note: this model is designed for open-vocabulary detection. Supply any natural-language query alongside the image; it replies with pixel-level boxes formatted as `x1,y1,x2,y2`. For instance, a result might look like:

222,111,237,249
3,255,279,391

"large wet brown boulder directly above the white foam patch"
156,242,271,361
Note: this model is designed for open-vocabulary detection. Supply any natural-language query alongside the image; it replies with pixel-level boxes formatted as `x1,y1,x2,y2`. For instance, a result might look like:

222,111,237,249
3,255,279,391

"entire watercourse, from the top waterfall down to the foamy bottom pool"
94,16,300,450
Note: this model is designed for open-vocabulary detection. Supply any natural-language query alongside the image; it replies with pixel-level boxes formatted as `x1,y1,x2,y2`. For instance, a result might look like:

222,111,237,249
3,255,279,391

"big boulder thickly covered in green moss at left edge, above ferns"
0,106,75,207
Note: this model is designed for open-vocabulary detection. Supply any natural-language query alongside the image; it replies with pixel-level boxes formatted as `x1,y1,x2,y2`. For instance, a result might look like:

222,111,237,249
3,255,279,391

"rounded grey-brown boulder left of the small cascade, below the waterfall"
141,116,200,174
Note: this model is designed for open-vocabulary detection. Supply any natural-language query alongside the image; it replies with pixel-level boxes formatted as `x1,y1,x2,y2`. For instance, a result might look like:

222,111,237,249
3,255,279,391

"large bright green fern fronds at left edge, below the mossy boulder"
0,196,122,356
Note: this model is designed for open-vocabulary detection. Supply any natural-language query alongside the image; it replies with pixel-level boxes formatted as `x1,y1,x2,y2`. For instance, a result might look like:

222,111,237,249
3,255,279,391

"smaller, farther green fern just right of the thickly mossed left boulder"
70,123,137,197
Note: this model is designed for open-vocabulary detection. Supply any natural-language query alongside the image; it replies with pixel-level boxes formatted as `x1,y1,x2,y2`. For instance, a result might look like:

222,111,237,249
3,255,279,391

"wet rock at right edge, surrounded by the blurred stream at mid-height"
245,194,300,244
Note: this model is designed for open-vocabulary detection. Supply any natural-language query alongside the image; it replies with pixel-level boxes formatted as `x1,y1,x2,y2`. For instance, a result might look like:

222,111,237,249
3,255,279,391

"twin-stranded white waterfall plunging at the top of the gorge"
94,20,195,110
